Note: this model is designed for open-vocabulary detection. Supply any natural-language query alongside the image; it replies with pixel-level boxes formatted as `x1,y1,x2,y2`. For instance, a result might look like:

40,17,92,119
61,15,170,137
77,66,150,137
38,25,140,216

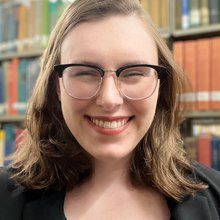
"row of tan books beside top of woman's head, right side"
140,0,169,30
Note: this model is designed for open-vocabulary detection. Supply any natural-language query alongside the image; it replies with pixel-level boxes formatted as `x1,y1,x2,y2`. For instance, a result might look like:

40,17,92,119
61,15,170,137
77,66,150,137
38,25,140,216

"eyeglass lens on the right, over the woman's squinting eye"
119,66,158,100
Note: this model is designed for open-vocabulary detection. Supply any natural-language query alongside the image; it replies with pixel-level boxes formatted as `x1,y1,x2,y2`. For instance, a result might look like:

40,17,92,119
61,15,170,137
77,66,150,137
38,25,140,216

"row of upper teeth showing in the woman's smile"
90,117,131,129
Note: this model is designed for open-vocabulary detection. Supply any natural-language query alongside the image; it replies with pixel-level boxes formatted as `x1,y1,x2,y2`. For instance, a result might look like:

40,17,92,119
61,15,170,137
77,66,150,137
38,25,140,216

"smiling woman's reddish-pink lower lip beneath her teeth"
87,119,130,135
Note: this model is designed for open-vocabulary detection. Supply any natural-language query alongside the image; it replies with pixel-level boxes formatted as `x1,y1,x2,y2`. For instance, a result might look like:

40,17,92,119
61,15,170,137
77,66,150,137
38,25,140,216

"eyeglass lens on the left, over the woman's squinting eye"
63,66,102,99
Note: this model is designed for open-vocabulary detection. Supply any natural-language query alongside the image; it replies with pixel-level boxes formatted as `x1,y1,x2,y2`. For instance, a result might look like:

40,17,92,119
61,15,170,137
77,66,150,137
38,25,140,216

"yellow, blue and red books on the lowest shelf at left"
0,123,23,166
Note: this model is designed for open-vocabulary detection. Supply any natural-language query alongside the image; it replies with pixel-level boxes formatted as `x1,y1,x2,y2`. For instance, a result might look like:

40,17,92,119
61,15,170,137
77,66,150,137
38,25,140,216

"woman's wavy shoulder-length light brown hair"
12,0,204,200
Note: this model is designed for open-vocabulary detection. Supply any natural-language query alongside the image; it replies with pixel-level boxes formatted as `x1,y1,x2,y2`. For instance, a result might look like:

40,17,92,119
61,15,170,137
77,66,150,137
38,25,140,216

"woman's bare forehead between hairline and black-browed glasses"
61,15,158,64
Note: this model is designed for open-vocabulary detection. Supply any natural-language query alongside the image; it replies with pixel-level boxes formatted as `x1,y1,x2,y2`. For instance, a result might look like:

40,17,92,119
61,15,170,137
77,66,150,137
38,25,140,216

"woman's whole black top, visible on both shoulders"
0,163,220,220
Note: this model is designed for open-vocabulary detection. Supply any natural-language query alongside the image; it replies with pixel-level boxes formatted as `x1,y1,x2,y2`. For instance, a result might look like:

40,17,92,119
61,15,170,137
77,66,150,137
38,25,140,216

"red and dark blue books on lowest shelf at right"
184,123,220,170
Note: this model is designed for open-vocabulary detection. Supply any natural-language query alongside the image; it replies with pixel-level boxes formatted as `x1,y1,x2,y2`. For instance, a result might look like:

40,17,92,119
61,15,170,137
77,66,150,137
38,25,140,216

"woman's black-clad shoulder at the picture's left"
0,168,65,220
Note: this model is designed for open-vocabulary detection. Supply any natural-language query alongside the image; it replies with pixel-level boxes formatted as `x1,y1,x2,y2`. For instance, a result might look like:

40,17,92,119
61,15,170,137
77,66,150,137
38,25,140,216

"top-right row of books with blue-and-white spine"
175,0,220,29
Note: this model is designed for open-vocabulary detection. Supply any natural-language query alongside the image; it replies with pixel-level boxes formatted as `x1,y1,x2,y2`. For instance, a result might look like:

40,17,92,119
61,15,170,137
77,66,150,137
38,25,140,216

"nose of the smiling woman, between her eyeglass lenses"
96,73,124,111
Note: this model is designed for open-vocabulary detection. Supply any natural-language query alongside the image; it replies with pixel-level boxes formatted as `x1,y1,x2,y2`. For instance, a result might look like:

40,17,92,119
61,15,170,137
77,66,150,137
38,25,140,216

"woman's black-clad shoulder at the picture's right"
171,162,220,220
